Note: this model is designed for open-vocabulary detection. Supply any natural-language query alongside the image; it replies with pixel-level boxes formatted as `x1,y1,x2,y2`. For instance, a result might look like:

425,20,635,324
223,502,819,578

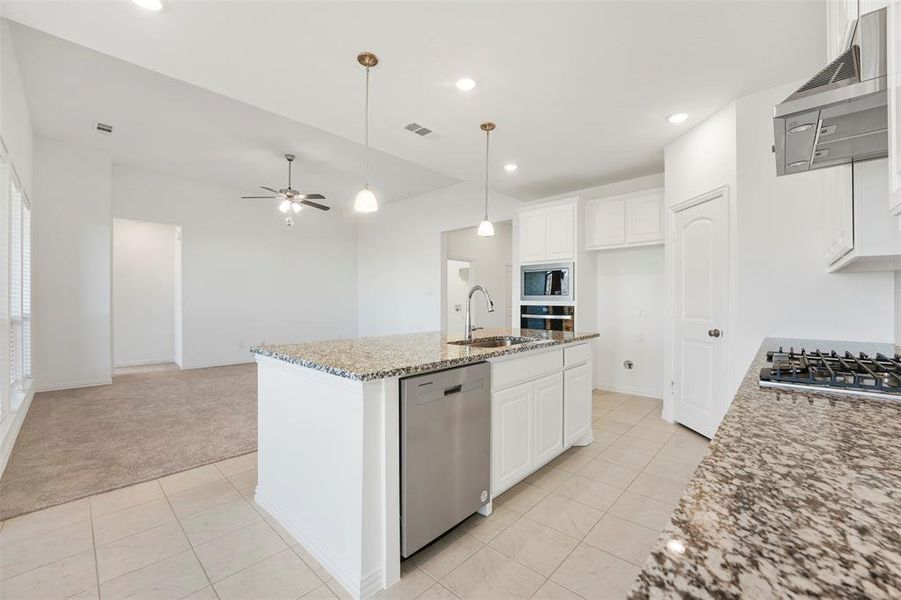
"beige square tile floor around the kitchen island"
0,392,707,600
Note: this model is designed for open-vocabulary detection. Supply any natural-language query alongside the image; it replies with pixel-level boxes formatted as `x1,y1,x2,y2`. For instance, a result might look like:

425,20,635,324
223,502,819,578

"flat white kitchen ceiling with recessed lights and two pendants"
4,0,825,200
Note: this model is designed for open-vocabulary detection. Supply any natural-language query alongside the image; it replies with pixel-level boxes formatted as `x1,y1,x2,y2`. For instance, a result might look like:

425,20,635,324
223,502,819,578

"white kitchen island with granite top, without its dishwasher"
253,329,597,598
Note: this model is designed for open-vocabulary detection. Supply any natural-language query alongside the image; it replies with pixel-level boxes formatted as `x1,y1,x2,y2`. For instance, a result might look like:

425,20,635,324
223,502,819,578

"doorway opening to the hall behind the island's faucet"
441,221,513,336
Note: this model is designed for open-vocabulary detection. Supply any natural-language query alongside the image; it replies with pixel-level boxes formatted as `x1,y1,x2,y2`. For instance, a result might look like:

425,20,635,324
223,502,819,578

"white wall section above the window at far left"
0,18,34,193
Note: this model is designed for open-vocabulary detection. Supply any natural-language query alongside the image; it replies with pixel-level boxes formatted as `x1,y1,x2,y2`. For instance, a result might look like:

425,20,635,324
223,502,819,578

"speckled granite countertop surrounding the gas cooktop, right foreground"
631,339,901,599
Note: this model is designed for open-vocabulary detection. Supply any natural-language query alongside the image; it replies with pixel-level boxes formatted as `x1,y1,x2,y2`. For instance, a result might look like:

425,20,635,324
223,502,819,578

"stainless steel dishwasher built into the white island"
400,363,491,557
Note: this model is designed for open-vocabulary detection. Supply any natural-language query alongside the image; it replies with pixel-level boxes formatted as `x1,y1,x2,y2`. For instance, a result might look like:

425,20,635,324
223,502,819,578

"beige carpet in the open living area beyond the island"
0,364,257,520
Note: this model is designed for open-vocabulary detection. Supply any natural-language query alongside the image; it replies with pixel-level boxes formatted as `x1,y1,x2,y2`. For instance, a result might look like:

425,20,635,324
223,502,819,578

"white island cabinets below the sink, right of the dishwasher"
490,344,591,498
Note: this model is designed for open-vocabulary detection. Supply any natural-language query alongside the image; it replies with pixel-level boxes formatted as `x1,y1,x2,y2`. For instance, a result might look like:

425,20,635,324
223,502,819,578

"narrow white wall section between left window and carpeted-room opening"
32,137,112,389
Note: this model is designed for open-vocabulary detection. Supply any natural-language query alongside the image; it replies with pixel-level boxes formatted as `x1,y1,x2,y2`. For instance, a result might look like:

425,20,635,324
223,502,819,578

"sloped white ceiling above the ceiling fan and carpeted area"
5,24,456,212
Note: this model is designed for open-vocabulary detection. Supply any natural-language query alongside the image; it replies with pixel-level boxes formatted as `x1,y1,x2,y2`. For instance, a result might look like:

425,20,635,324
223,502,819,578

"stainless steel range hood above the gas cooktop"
773,8,888,175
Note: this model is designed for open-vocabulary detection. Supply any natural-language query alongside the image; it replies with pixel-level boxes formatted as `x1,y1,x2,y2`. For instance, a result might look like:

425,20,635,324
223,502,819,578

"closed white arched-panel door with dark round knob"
673,191,729,437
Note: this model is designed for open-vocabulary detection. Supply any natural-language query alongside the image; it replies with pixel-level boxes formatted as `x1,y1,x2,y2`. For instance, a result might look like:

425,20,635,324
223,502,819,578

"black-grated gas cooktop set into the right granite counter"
760,346,901,399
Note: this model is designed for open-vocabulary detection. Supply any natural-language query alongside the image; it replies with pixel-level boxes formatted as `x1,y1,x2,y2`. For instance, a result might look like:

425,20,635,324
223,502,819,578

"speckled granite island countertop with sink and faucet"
251,329,598,381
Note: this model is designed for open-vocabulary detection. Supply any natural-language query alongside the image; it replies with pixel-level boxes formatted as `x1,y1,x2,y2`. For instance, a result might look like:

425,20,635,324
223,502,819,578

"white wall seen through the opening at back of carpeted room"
113,219,175,367
